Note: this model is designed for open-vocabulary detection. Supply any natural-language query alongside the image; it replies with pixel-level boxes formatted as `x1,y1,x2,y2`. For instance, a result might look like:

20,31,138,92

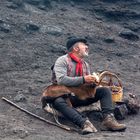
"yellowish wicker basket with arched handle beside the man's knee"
99,71,123,102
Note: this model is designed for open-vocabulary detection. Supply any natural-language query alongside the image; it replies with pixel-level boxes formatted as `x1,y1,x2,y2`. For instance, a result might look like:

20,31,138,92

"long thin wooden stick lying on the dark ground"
2,97,78,131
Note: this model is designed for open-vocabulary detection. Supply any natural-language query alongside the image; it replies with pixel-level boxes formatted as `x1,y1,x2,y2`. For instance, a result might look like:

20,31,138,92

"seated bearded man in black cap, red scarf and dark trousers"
50,38,126,134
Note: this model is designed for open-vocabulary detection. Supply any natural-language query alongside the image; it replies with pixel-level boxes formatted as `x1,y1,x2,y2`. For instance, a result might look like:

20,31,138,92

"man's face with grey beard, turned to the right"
76,42,89,58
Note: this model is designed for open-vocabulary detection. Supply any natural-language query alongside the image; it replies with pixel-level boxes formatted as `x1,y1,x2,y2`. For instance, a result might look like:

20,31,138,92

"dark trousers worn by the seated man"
52,87,113,127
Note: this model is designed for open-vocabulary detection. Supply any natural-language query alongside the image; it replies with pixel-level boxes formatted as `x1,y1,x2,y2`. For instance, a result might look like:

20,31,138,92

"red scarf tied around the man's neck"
69,53,83,76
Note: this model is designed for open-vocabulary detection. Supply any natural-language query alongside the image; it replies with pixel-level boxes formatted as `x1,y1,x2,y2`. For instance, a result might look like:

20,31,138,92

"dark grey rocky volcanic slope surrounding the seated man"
0,0,140,140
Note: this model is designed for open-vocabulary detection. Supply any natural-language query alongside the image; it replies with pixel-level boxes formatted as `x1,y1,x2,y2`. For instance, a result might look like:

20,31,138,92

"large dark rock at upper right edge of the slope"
119,30,139,41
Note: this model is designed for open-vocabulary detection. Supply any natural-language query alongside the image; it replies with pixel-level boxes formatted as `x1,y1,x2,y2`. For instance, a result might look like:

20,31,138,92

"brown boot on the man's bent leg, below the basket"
102,114,126,131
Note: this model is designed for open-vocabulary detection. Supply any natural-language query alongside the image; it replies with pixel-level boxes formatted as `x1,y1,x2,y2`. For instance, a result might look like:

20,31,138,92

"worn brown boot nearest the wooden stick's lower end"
82,120,97,135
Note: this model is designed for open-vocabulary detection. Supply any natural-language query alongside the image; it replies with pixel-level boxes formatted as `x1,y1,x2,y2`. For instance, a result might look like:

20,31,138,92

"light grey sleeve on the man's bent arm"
54,57,84,86
